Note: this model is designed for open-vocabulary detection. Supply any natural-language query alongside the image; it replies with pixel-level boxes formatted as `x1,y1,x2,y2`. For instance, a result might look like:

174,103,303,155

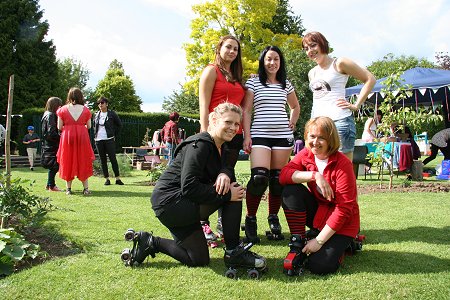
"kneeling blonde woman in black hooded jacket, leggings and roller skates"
124,103,266,270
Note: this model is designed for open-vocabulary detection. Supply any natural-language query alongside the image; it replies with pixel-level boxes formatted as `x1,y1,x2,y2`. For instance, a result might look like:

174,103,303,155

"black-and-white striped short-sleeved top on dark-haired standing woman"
246,77,294,139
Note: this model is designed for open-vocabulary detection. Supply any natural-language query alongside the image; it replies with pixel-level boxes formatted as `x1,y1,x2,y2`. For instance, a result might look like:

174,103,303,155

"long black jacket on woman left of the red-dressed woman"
41,111,60,169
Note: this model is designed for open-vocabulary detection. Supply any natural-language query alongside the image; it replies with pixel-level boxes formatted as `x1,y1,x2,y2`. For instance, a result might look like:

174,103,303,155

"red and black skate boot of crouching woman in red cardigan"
283,234,308,276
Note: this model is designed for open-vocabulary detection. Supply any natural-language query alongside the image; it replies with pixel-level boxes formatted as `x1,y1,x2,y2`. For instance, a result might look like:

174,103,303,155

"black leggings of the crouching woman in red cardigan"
283,184,352,275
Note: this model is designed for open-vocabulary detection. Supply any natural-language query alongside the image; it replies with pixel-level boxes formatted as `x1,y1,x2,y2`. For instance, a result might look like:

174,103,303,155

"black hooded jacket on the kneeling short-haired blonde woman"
151,132,233,216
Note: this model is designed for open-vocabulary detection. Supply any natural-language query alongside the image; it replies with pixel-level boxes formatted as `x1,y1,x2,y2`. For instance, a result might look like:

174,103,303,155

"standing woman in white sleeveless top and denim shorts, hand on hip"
302,31,375,160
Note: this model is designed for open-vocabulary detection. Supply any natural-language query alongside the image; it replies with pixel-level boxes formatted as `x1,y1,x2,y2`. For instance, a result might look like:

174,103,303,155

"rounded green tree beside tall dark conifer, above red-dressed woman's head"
55,58,90,99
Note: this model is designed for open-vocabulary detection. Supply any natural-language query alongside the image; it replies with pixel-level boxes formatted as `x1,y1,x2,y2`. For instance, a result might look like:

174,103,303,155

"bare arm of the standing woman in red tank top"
198,66,217,131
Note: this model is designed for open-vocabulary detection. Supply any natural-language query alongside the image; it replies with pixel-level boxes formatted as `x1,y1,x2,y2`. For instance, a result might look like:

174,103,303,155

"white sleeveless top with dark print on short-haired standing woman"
309,58,352,121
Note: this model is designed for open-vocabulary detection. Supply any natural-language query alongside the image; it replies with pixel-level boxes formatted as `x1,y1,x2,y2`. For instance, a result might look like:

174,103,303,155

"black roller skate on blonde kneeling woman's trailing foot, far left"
120,229,157,267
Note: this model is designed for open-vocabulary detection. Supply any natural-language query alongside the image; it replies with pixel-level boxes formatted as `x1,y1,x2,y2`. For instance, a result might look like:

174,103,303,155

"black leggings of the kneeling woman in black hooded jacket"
156,199,242,267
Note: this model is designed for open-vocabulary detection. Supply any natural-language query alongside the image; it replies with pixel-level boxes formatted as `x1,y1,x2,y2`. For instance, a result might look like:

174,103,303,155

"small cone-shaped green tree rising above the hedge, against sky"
94,59,142,112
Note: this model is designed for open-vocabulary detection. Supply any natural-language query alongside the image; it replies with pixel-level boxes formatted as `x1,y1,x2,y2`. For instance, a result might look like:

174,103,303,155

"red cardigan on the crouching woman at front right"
280,148,360,237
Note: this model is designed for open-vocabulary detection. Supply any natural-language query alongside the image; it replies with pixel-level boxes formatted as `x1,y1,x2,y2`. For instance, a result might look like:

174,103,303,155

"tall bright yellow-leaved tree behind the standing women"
169,0,304,113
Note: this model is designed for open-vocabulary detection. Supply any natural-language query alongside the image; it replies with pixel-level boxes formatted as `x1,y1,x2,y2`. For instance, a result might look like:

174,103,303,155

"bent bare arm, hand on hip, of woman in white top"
336,57,375,111
